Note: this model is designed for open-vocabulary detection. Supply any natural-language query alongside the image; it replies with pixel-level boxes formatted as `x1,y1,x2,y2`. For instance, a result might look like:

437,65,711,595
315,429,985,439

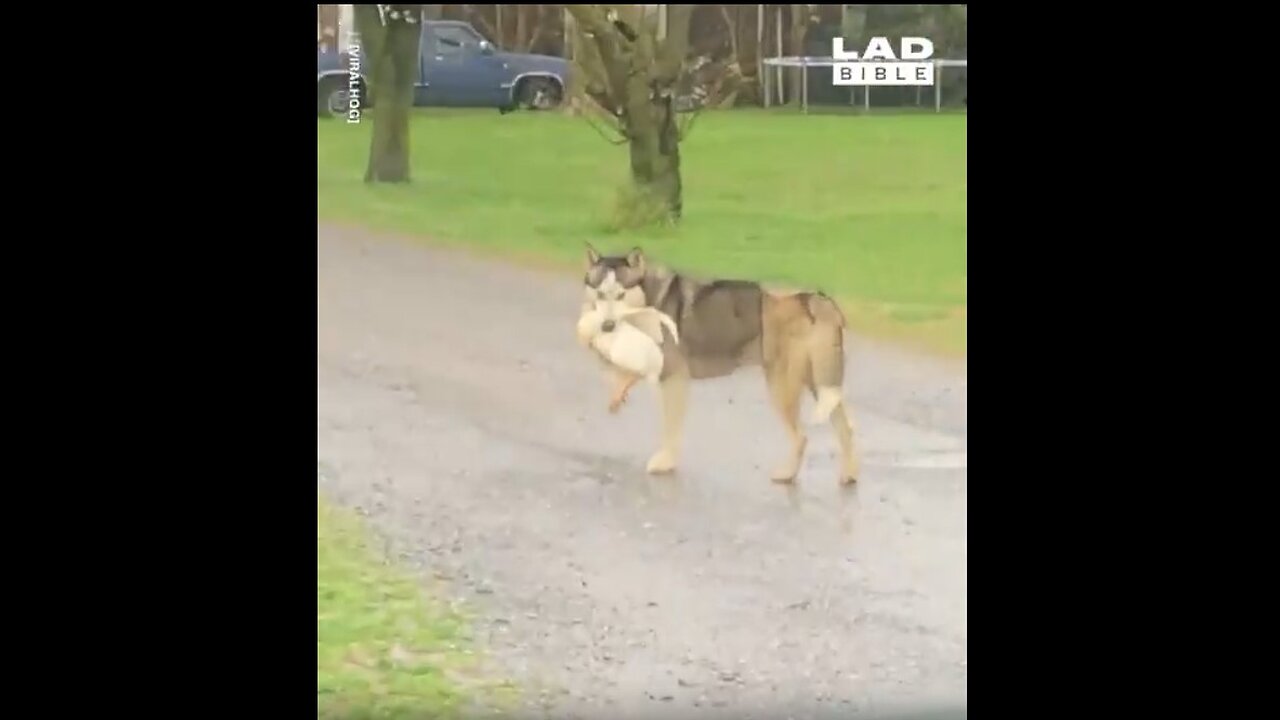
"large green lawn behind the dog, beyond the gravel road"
316,110,968,355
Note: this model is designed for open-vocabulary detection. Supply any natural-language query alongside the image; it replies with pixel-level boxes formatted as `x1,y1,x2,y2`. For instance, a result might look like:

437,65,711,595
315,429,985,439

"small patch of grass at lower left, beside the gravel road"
316,497,513,720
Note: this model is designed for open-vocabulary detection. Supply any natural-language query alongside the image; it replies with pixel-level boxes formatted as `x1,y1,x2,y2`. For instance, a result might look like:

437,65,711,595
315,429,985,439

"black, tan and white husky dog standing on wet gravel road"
582,246,859,484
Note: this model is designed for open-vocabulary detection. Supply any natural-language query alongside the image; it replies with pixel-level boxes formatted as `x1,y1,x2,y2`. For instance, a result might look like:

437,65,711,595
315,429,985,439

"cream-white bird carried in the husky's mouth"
577,300,680,413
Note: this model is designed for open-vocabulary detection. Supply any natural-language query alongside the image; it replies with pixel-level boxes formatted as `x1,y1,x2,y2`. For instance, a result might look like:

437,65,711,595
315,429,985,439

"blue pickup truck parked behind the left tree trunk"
316,20,568,115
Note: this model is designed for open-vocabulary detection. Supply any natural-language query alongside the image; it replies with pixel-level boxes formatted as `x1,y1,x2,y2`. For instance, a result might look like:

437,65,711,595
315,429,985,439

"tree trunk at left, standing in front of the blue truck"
355,5,422,182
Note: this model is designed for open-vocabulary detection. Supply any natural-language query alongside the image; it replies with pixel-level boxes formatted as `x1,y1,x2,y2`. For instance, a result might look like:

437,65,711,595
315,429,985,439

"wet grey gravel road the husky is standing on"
316,225,968,719
